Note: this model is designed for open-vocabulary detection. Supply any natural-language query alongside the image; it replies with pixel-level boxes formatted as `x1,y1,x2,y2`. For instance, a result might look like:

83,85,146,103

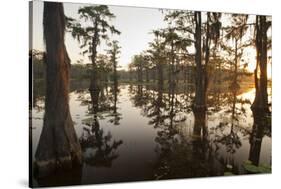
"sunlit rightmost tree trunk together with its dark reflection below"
249,16,270,166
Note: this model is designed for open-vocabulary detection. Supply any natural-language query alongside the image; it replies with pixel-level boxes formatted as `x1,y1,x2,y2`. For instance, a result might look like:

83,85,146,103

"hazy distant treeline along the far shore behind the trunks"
32,51,253,85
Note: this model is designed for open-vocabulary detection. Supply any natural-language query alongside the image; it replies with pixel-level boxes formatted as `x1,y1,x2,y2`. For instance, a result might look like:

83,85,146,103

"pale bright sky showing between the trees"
32,1,271,76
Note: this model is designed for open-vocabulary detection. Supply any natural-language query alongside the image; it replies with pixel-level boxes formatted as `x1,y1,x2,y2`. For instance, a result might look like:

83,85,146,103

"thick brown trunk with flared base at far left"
35,2,82,177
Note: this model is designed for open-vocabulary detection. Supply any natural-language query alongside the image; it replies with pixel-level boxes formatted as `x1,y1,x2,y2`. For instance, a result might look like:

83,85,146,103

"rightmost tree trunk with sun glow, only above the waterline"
252,16,269,112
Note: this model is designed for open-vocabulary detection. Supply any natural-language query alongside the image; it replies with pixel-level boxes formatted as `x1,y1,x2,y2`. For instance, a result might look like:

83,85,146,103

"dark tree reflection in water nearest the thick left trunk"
79,85,123,167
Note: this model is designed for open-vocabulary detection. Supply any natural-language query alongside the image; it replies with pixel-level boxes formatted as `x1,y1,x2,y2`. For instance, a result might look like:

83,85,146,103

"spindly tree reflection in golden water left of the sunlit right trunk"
209,87,250,171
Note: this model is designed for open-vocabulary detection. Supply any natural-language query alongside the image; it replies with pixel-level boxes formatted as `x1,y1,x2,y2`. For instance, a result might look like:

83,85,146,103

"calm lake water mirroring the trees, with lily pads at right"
30,83,272,186
